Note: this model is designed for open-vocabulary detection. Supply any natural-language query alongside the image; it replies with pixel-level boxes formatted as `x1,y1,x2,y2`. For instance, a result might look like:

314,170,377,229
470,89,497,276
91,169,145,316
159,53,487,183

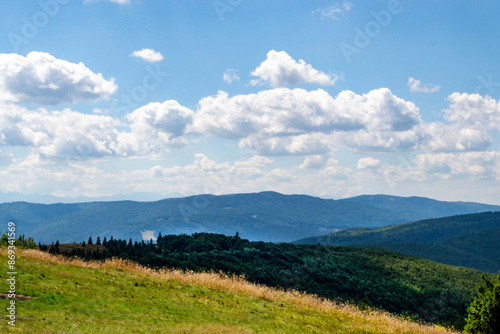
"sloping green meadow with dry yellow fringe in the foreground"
0,249,458,333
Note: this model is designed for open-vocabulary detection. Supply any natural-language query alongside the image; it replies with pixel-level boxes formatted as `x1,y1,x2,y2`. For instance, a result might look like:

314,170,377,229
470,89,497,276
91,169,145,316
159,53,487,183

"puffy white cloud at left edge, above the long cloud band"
0,52,118,105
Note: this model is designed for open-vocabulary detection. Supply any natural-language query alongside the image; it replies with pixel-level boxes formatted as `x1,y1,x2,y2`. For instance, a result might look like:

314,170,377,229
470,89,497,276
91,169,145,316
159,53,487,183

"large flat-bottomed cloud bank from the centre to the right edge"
189,88,500,155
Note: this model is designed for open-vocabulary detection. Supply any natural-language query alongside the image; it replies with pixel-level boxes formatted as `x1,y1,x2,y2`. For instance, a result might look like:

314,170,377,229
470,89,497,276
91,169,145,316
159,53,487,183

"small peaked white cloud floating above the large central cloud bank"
251,50,338,87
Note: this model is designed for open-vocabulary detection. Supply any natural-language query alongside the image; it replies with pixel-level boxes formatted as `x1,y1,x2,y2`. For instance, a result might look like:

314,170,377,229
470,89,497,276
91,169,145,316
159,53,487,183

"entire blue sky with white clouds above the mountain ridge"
0,0,500,204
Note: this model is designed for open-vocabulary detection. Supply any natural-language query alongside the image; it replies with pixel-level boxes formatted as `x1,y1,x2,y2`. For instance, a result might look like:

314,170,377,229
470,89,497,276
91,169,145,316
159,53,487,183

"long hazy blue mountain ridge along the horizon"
0,192,500,243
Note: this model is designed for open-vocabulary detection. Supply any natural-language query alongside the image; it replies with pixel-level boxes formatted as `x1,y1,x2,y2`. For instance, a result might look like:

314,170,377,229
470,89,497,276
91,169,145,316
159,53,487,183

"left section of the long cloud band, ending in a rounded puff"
0,100,197,162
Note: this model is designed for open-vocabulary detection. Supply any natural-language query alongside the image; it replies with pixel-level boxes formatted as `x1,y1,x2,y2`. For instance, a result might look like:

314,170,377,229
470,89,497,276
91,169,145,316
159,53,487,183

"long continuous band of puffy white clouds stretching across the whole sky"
0,83,497,164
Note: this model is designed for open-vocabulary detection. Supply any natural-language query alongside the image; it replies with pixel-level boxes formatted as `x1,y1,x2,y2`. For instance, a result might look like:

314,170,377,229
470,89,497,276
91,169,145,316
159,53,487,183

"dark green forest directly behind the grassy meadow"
45,233,490,328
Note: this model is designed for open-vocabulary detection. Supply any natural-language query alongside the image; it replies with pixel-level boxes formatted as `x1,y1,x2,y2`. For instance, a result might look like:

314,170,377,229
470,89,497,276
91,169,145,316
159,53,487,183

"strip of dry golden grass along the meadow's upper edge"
16,248,459,334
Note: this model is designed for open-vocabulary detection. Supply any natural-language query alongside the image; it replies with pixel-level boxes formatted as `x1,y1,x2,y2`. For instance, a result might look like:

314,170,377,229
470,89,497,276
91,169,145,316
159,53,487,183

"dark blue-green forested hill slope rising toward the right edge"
295,212,500,273
